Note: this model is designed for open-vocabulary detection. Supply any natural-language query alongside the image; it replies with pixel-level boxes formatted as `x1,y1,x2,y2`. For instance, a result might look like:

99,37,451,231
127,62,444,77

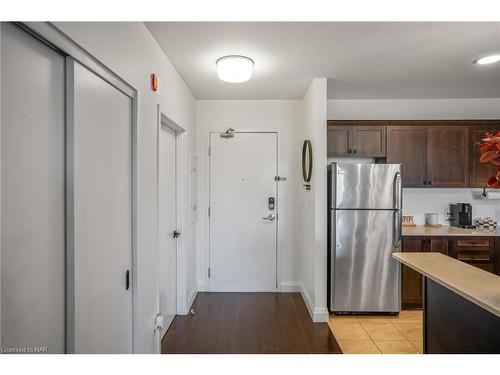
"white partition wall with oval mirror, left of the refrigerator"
294,78,328,321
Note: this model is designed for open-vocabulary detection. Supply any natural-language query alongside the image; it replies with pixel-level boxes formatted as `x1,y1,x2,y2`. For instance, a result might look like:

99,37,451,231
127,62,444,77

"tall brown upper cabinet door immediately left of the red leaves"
427,126,469,187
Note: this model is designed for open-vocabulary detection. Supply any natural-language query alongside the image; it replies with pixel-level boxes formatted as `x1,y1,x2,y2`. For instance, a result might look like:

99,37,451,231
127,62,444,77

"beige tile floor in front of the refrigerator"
328,310,423,354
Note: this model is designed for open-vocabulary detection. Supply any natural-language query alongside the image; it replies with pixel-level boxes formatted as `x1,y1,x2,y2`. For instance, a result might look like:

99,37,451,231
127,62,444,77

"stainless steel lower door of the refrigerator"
330,210,401,312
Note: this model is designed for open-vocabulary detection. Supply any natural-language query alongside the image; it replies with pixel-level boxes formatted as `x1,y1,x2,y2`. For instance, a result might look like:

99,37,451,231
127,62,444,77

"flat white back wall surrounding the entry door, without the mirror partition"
197,100,302,291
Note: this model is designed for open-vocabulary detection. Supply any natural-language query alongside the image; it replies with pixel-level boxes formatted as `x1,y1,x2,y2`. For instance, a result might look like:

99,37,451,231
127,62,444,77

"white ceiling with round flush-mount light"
145,22,500,99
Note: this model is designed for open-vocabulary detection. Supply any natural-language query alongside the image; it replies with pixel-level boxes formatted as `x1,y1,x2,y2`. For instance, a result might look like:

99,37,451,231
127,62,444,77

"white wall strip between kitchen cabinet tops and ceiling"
328,98,500,120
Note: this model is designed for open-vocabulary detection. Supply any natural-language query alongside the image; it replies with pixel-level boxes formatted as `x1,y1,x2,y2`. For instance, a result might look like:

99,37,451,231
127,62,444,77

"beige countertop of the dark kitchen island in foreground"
392,252,500,317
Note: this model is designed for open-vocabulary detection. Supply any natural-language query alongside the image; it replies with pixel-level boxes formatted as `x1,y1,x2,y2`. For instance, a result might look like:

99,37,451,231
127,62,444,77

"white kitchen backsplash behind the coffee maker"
403,188,500,225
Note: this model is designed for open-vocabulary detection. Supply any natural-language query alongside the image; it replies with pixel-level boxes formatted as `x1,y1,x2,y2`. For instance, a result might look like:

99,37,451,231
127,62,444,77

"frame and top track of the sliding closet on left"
11,22,139,353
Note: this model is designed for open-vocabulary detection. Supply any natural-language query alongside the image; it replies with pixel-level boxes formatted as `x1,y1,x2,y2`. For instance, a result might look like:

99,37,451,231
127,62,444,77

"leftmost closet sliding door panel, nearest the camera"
1,23,65,353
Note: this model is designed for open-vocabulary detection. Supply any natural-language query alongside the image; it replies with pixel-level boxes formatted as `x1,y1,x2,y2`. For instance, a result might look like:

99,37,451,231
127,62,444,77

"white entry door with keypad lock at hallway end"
209,133,278,292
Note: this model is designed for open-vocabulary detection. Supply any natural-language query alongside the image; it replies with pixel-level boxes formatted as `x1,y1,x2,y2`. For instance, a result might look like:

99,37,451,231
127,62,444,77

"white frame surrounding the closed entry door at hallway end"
205,129,282,292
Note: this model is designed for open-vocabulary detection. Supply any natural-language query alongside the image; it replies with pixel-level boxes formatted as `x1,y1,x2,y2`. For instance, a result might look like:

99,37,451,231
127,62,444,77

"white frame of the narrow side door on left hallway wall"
155,104,187,353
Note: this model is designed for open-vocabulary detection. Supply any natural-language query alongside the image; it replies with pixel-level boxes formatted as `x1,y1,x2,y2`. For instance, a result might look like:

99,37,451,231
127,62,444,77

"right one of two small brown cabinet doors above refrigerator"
352,126,386,157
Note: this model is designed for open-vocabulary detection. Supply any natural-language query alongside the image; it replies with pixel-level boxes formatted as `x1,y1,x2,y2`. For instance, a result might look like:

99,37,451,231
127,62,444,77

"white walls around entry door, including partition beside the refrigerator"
197,92,328,321
